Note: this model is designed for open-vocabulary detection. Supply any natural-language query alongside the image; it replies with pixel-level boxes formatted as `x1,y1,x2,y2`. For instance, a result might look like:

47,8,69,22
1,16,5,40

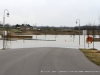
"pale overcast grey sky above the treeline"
0,0,100,26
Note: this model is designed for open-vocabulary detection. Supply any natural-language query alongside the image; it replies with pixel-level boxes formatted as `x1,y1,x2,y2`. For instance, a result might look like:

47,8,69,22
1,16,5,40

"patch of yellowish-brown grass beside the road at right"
80,49,100,66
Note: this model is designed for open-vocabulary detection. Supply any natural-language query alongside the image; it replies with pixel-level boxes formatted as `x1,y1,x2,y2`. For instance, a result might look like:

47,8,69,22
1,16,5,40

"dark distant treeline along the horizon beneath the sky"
0,24,100,30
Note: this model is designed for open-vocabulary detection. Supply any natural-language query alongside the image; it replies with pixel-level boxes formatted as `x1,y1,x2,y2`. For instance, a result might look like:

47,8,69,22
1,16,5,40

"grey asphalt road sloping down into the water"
0,48,100,75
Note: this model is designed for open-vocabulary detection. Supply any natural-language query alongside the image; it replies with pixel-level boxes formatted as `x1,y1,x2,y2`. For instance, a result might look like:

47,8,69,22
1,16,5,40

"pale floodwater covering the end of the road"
0,35,100,50
